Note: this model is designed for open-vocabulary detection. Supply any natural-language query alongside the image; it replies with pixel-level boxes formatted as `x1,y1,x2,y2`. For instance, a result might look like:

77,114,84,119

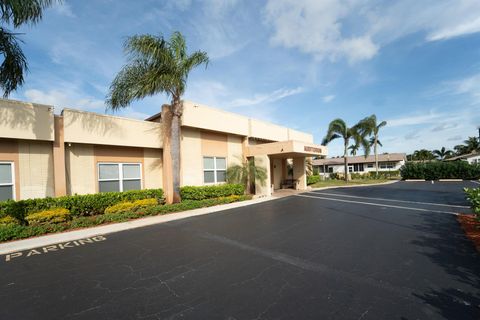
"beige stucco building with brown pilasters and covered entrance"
0,99,327,200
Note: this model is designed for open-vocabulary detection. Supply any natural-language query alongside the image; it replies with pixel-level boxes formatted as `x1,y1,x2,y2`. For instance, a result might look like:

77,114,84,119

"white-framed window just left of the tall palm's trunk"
98,163,142,192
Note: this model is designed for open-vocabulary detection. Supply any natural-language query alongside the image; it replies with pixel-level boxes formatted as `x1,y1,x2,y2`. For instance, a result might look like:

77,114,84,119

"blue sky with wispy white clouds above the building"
11,0,480,156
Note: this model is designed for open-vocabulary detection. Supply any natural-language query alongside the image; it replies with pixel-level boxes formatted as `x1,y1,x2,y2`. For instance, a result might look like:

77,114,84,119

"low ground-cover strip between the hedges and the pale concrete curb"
0,195,252,242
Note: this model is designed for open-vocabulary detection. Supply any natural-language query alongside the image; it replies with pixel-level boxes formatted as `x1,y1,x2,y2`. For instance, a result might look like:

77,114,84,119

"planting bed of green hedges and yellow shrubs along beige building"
0,185,248,242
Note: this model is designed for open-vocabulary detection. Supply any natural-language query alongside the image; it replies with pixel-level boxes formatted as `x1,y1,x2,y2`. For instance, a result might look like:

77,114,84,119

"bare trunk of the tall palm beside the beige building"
171,98,183,203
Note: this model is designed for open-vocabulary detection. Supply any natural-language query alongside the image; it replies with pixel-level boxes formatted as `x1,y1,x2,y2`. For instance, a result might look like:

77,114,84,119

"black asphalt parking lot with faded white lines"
0,182,480,320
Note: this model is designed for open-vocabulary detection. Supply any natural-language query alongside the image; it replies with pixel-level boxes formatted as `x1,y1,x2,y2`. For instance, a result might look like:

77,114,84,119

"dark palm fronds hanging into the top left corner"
0,0,61,98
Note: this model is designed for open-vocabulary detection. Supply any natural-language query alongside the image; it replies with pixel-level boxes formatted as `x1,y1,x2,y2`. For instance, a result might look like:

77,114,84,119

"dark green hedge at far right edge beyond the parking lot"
400,161,480,180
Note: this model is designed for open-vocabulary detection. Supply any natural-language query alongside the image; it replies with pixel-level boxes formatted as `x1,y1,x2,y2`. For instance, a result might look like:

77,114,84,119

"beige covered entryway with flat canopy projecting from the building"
247,140,327,195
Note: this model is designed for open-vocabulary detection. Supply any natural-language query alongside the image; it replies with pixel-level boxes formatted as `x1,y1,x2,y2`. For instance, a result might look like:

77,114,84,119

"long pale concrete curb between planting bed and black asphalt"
0,196,278,254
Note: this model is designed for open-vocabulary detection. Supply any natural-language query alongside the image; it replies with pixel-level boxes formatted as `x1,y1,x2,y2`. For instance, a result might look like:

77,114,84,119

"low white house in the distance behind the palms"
312,153,407,175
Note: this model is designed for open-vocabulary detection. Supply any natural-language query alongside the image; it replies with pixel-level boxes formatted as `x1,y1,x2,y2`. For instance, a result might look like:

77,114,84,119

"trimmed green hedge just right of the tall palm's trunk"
180,184,245,201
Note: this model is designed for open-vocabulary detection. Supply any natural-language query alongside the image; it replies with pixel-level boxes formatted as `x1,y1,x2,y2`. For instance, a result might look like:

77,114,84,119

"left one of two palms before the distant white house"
322,119,370,181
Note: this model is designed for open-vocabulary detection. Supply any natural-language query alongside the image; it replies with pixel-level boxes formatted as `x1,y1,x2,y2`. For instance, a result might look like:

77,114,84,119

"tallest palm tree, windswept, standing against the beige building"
106,32,208,202
